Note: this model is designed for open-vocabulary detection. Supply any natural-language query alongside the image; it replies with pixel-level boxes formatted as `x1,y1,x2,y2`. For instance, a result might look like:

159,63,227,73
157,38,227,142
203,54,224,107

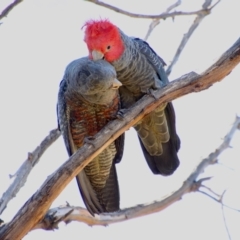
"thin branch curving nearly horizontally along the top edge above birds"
85,0,210,19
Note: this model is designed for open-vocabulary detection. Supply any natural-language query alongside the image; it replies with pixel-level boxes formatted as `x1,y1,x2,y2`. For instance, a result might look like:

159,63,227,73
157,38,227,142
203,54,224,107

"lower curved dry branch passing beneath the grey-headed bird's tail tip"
30,117,240,230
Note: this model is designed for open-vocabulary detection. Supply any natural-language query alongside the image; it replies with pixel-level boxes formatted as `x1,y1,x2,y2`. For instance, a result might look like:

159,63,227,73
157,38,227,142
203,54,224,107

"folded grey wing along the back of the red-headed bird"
133,38,169,86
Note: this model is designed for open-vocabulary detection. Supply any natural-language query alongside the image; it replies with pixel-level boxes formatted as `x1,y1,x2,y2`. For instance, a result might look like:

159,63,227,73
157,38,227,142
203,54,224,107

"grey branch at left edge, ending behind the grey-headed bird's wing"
0,129,60,214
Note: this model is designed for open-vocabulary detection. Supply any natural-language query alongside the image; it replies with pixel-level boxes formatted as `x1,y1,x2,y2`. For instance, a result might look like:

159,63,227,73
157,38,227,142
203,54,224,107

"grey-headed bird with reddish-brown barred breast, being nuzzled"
57,57,124,215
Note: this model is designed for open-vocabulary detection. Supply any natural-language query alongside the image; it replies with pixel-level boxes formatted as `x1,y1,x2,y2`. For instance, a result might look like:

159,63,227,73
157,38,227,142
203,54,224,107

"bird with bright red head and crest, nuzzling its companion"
83,19,181,176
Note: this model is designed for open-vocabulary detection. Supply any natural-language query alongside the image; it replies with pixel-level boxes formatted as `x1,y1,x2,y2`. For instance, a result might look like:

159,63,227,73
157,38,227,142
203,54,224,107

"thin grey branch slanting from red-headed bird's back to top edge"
166,0,220,76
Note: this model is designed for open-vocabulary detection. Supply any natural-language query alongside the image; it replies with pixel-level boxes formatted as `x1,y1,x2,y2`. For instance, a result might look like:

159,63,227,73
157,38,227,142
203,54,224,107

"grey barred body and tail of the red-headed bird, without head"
112,32,180,175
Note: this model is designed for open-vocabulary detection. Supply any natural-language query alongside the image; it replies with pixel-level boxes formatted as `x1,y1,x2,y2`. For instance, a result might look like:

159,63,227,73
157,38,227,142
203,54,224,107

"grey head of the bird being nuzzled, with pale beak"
64,57,122,105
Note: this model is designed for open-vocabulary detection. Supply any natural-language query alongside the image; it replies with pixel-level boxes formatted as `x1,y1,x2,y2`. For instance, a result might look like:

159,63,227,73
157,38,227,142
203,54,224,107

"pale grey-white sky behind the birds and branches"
0,0,240,240
